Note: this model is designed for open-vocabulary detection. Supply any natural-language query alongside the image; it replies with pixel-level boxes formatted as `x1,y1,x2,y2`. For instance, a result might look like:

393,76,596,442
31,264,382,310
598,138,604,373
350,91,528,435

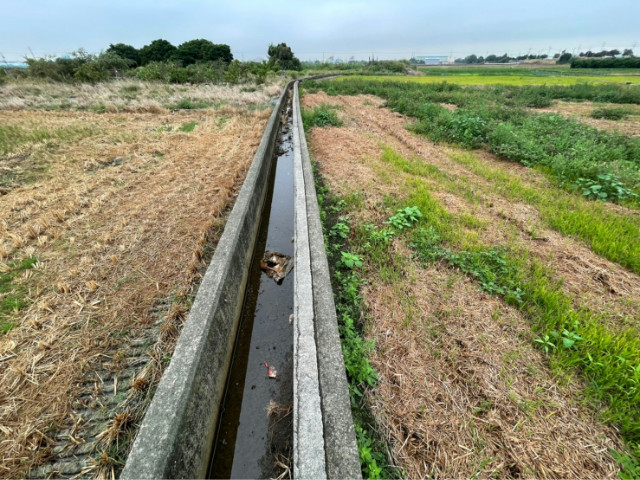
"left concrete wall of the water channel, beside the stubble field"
120,83,291,479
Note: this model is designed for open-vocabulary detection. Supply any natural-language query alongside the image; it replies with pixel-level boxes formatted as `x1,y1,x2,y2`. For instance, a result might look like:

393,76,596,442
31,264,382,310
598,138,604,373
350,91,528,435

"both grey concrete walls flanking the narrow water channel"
121,82,362,479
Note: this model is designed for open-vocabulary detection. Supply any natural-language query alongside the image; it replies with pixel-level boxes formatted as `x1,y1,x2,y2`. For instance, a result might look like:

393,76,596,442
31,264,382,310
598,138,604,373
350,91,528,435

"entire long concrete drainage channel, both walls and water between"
121,82,361,478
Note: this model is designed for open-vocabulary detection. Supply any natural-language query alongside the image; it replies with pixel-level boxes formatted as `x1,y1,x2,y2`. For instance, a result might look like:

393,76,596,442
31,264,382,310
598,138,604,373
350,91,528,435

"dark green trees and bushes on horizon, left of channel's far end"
17,39,302,83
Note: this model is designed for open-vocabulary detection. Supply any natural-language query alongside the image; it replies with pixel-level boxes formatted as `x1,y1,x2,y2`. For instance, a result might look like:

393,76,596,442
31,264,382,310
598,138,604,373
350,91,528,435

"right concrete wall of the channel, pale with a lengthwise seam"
293,82,362,479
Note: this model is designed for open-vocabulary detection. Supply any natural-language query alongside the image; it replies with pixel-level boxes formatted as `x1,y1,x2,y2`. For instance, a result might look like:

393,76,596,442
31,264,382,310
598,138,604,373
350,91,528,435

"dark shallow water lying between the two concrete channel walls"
209,105,295,478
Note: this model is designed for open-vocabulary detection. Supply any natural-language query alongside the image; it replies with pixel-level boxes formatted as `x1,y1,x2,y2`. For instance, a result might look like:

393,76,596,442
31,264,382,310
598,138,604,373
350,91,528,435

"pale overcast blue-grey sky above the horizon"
0,0,640,61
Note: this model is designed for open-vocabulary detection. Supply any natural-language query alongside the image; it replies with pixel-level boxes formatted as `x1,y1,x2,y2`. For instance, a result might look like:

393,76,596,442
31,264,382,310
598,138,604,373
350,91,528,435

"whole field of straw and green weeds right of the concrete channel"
303,79,640,478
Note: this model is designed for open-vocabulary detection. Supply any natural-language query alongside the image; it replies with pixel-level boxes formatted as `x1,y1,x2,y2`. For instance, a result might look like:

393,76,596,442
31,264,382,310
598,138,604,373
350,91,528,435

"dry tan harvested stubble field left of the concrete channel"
0,94,270,478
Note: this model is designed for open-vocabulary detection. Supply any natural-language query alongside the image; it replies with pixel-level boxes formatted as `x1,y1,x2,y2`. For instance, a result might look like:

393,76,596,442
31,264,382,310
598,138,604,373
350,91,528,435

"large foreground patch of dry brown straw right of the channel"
364,266,620,478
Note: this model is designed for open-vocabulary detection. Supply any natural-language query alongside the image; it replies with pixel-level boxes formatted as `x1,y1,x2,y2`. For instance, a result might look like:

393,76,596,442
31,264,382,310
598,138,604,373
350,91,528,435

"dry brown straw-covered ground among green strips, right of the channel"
303,92,640,478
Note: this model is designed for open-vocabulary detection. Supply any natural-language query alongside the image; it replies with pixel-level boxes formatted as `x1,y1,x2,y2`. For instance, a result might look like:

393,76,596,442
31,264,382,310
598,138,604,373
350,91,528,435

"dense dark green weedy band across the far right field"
305,78,640,206
